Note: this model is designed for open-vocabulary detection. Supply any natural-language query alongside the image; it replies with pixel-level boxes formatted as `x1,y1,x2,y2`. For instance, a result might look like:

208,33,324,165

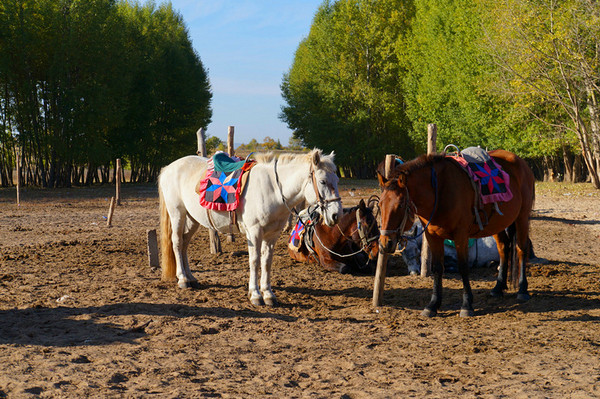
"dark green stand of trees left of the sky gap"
0,0,211,186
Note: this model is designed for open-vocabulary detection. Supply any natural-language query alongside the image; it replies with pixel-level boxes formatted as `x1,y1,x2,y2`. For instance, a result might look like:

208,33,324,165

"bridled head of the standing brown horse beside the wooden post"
377,171,415,253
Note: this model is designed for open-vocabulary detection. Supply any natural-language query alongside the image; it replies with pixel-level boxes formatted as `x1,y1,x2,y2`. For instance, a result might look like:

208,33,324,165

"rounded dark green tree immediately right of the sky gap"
281,0,413,177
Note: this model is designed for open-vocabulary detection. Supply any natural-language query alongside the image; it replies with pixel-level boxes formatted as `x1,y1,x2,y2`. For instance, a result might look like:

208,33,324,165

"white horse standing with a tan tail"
158,149,342,306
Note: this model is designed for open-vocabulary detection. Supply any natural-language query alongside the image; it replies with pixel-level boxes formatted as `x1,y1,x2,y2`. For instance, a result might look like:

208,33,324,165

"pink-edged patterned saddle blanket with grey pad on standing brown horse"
450,147,513,204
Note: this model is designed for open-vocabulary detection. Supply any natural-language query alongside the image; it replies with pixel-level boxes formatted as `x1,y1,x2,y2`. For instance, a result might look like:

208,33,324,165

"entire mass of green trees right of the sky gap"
281,0,600,184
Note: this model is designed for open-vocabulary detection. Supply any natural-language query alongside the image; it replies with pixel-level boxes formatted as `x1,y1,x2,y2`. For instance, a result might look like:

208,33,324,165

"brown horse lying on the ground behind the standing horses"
288,200,379,273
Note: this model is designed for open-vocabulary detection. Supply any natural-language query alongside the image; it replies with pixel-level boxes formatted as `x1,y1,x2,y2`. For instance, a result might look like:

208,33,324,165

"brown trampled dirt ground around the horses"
0,181,600,399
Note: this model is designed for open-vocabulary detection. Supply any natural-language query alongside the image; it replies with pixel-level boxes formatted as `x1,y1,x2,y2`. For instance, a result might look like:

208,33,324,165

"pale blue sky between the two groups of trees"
165,0,323,145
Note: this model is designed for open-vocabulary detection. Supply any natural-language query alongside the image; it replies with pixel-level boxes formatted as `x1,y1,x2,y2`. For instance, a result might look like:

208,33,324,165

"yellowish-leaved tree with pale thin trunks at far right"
490,0,600,188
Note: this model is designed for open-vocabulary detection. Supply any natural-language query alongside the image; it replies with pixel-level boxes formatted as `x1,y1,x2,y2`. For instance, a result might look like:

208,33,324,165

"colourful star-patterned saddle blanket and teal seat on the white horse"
196,152,255,211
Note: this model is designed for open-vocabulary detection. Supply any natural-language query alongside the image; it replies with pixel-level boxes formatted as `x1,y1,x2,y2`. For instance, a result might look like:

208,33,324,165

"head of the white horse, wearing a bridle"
304,149,342,226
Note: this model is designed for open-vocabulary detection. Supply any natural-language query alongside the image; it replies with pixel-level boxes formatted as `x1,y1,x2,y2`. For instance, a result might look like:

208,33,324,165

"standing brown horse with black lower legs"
378,150,535,317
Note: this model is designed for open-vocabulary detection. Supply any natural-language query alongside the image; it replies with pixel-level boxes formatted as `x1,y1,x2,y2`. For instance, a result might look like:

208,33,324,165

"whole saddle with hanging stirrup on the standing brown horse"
444,144,513,230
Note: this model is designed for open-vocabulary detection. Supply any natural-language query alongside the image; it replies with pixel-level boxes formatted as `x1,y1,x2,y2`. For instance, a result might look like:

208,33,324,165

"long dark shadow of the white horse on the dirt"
0,303,297,347
